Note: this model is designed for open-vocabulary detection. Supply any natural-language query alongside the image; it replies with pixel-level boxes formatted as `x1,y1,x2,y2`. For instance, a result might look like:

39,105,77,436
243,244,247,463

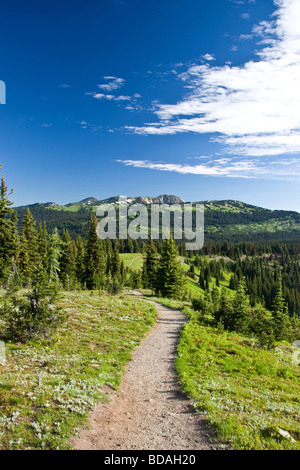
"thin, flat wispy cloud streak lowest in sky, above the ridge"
117,156,300,180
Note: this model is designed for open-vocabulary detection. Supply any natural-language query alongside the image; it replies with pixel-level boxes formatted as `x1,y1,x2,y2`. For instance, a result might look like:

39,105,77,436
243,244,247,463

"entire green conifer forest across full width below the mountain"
0,169,300,344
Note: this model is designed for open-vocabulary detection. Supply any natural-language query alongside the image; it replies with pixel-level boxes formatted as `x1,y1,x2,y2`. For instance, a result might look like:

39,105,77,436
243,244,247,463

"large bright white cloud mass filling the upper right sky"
127,0,300,156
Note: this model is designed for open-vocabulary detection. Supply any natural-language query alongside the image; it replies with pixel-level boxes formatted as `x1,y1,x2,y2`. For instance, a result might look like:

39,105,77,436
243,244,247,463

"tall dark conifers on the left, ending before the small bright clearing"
0,174,124,290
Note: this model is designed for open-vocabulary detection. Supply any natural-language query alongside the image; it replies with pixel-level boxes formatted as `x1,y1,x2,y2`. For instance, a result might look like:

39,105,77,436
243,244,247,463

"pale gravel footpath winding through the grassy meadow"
70,291,223,450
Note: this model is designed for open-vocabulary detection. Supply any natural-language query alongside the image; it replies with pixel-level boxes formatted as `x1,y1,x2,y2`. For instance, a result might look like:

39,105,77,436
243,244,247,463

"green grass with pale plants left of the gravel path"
0,291,156,450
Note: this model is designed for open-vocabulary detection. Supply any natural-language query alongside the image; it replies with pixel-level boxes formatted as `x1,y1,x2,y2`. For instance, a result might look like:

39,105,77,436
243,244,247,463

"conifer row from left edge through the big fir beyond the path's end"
0,173,184,298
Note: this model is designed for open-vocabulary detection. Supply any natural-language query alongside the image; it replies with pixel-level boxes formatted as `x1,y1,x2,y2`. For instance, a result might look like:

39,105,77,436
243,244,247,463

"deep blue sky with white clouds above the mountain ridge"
0,0,300,211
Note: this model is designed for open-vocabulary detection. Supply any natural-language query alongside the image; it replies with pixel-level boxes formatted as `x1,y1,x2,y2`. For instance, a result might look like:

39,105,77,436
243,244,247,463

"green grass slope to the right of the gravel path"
176,319,300,450
